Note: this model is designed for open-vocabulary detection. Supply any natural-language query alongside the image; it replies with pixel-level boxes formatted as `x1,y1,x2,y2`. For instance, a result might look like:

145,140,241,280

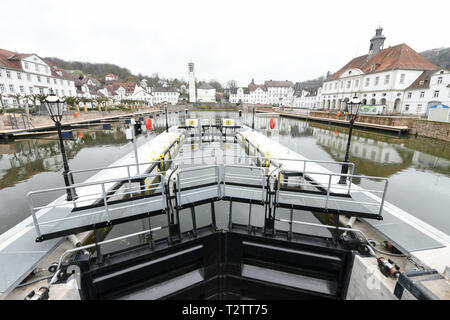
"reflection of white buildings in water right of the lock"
280,118,450,177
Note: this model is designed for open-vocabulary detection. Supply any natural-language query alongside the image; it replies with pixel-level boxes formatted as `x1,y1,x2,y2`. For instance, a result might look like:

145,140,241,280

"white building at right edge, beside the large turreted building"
402,69,450,115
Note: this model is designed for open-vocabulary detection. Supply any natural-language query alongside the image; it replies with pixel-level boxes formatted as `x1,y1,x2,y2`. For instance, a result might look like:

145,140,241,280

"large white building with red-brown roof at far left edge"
0,49,76,108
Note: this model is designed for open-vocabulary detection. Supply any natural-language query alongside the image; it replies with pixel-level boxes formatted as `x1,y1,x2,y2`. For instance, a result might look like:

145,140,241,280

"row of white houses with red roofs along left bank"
0,49,183,108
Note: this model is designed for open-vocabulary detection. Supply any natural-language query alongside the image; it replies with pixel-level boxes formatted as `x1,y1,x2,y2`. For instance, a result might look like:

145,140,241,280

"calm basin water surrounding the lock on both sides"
0,111,450,242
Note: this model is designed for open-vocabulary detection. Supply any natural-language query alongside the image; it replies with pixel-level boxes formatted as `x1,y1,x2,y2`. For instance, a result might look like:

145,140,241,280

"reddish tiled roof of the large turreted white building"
325,43,439,81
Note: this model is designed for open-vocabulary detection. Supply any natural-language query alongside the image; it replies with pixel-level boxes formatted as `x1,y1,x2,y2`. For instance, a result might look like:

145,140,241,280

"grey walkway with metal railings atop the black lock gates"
27,159,389,242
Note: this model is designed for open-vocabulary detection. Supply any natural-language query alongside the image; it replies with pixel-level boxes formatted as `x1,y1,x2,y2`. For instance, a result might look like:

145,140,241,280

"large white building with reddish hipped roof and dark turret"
321,28,439,113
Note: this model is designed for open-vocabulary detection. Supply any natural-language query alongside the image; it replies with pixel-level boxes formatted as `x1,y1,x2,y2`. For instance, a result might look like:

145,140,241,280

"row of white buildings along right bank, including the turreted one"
230,27,450,115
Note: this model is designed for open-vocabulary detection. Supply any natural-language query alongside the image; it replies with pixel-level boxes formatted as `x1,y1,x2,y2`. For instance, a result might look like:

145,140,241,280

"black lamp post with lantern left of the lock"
44,89,77,201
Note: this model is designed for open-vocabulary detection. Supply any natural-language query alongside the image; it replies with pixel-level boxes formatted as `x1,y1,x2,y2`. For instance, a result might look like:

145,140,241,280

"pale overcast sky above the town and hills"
0,0,450,85
